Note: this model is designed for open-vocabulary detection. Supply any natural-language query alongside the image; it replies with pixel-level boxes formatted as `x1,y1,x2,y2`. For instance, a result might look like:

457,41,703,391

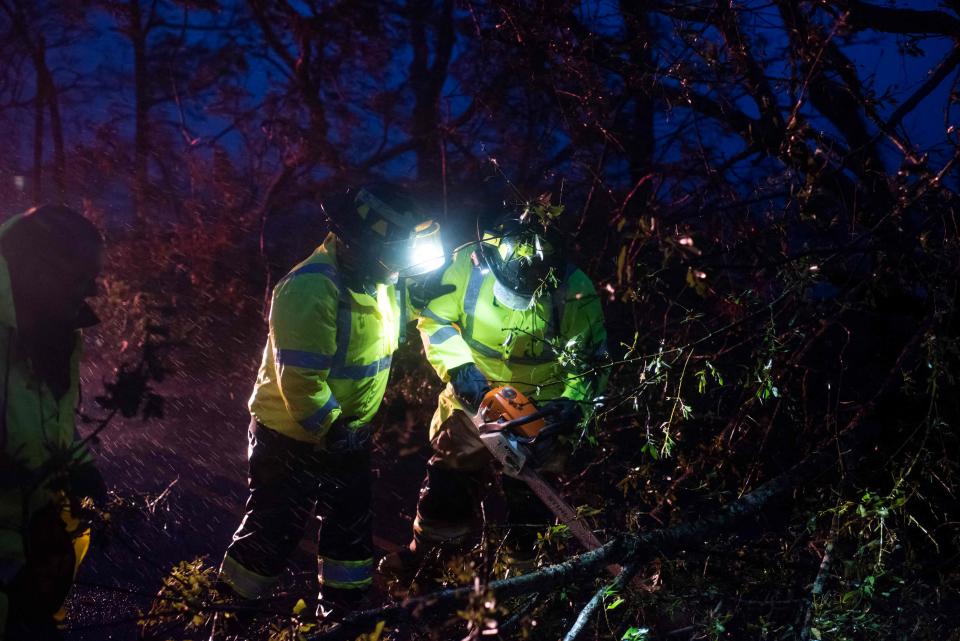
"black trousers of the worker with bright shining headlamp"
220,421,373,599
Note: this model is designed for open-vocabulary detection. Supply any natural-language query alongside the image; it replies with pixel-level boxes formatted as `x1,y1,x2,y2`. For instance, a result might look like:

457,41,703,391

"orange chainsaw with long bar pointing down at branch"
472,386,613,571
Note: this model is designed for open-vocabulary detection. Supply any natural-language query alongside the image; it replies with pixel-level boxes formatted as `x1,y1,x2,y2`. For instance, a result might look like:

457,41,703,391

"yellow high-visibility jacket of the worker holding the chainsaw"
417,247,607,437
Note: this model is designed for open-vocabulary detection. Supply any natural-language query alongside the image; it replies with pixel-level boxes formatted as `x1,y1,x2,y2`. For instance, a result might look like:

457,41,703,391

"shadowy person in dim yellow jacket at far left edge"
0,205,106,641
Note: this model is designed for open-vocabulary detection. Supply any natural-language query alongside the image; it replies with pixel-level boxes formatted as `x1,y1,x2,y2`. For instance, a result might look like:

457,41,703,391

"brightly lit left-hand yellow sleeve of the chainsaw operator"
417,250,473,383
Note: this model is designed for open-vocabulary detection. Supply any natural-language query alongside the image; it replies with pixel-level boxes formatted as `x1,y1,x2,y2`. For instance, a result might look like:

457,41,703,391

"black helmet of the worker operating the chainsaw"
479,217,563,310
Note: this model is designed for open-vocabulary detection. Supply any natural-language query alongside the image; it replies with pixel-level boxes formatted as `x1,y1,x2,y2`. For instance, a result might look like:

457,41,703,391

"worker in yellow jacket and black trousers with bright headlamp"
211,184,444,639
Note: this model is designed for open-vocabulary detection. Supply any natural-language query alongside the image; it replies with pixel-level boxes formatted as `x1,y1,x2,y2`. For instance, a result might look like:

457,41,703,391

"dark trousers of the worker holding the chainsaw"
413,410,567,548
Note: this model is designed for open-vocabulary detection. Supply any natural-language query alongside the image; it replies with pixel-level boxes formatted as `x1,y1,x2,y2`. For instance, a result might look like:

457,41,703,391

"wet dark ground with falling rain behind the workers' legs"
65,352,435,641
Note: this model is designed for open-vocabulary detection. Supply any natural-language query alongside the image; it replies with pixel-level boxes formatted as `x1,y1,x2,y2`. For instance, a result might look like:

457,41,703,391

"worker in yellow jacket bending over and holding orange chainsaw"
381,218,607,576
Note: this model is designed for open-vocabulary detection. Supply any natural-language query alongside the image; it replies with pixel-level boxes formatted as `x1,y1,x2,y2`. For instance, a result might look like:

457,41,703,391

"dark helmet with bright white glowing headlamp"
322,183,445,277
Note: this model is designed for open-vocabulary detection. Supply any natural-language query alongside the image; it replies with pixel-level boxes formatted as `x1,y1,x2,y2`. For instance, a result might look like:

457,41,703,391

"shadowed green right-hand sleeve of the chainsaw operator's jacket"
561,270,609,401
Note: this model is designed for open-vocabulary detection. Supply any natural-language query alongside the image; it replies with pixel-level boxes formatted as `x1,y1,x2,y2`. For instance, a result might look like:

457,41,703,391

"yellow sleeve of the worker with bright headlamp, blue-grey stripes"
270,274,341,436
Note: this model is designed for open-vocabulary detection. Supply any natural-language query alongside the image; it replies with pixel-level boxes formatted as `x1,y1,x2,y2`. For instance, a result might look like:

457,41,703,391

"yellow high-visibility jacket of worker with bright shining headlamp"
249,233,401,444
